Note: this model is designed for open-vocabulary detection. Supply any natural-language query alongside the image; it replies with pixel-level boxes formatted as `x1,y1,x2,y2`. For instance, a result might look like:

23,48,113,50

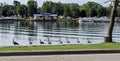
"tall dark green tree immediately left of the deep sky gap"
27,0,38,16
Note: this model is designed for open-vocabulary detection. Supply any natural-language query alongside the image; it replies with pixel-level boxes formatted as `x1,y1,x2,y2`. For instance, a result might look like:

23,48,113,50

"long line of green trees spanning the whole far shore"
0,0,117,18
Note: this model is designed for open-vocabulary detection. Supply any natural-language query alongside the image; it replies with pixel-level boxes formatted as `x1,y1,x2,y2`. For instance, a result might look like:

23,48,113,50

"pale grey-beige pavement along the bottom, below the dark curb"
0,53,120,61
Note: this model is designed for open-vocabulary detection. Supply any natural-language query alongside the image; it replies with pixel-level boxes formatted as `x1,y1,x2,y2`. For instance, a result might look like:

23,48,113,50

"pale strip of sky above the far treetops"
0,0,109,7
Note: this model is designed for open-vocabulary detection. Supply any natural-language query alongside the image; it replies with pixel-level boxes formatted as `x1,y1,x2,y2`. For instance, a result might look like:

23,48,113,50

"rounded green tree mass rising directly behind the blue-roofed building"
42,1,64,15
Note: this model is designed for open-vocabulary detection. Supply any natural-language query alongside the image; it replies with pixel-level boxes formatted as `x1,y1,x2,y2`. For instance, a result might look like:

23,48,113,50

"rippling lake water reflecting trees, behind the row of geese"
0,22,120,46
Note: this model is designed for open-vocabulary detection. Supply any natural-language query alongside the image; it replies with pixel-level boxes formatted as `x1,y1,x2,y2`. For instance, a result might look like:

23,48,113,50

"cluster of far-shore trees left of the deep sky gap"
0,0,38,17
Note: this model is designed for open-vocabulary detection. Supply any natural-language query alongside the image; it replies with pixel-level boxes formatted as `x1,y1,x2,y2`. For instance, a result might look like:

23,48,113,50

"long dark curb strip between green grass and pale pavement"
0,50,120,56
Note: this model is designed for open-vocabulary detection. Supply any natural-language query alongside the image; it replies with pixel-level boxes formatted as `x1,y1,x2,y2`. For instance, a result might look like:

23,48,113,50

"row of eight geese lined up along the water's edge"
12,37,91,46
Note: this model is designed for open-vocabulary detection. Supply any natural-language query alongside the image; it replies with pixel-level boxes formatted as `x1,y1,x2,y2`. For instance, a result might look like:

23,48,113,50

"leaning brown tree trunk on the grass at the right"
105,0,119,42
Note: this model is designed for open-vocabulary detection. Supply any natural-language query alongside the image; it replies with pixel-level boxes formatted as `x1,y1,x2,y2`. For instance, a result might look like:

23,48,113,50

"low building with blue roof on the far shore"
34,13,58,20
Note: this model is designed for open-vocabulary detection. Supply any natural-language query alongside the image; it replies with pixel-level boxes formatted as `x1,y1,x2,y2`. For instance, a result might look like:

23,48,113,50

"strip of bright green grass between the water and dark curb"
0,43,120,52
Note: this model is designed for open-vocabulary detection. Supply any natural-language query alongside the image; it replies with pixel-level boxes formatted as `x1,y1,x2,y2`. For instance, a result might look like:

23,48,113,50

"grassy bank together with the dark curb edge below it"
0,43,120,56
